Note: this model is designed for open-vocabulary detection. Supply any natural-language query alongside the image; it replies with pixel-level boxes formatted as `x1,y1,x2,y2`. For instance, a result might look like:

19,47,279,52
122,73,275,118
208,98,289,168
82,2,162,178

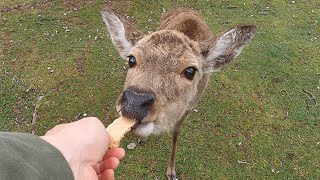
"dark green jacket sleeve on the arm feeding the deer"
0,132,74,180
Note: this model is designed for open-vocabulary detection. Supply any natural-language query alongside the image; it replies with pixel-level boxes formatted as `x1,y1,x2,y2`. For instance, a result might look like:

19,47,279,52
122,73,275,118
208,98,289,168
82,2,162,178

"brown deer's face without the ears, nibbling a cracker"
117,30,202,136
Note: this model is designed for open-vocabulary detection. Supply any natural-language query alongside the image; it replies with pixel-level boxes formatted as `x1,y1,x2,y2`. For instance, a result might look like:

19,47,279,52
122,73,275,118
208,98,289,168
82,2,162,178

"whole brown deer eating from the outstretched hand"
101,7,256,180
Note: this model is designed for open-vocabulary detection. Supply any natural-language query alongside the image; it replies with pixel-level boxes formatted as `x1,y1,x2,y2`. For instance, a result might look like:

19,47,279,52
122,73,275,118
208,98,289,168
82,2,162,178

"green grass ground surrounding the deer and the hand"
0,0,320,179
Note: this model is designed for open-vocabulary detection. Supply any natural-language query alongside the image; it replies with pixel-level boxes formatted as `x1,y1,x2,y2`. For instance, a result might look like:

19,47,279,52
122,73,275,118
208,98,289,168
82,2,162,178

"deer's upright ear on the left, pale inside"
101,11,133,59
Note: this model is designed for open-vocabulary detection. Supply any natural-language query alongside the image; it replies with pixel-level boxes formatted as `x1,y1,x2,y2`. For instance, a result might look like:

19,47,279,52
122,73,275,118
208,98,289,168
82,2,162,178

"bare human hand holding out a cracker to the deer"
41,117,125,180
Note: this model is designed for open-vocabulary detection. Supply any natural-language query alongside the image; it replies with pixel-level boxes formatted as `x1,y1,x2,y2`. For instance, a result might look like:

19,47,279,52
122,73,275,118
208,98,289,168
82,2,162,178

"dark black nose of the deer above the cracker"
121,89,155,121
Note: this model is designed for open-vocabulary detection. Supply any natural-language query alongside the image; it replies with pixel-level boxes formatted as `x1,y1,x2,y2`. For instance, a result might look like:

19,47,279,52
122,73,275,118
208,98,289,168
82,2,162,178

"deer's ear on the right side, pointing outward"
203,25,256,73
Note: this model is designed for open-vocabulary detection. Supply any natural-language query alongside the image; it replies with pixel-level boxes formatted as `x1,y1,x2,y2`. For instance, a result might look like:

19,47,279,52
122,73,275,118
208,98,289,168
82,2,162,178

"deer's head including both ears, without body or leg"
102,12,255,137
